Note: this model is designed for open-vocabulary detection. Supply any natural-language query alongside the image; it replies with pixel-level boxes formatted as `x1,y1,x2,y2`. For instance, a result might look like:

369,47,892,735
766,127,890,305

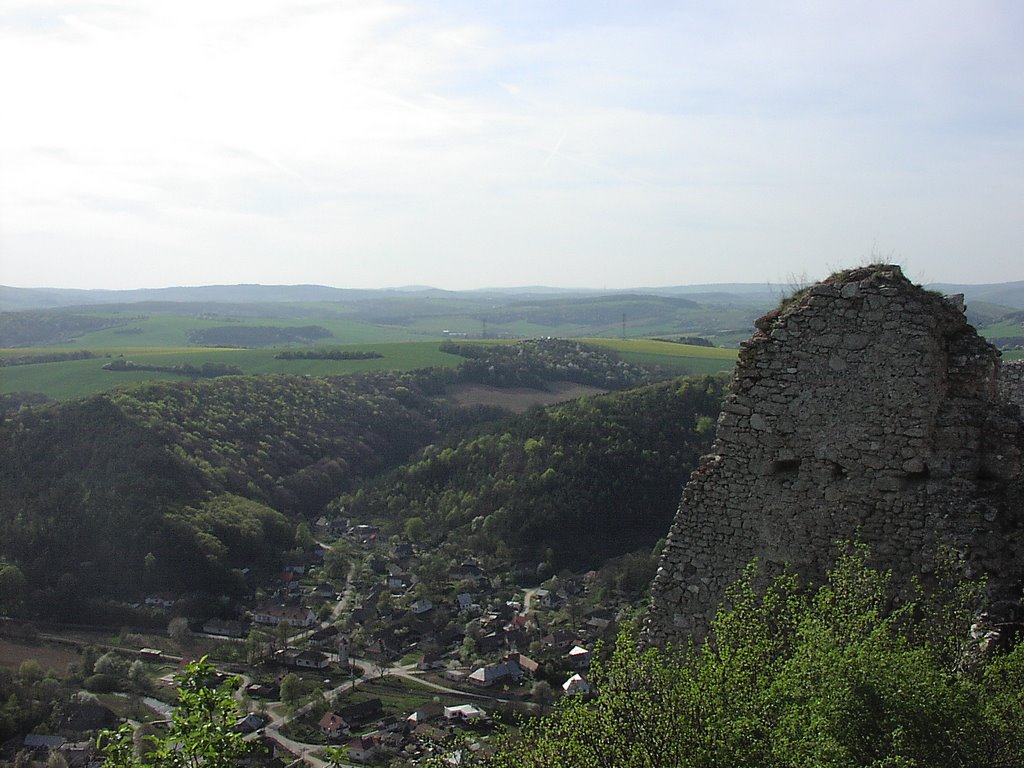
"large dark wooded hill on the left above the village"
0,374,471,606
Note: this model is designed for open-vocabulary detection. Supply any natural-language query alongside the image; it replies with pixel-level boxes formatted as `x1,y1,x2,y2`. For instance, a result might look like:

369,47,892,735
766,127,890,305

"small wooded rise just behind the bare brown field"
440,339,664,389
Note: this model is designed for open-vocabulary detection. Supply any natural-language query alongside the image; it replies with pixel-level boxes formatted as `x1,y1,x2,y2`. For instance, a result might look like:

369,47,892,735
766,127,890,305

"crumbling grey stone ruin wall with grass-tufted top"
647,265,1024,644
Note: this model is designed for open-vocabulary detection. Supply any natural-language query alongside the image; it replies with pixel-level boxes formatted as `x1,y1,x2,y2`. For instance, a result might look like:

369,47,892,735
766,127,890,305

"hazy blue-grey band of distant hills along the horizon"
0,282,1024,348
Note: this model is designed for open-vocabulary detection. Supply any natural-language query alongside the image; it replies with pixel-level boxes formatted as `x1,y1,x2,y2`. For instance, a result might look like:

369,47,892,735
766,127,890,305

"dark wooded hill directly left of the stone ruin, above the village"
335,378,725,569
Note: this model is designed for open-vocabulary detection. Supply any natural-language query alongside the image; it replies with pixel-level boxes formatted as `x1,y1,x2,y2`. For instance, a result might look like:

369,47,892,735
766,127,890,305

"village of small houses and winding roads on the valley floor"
7,518,628,766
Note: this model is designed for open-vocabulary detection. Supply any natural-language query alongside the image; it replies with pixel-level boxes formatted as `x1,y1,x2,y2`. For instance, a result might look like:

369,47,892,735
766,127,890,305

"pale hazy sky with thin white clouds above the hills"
0,0,1024,289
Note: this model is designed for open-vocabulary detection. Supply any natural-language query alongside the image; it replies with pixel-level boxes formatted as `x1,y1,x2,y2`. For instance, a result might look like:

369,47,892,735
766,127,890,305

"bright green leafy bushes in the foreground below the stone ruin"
482,548,1024,768
